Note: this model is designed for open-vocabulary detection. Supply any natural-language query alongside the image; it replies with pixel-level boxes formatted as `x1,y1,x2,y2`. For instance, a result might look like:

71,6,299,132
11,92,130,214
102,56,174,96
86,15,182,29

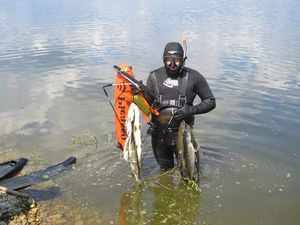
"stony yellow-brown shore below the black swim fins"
0,193,111,225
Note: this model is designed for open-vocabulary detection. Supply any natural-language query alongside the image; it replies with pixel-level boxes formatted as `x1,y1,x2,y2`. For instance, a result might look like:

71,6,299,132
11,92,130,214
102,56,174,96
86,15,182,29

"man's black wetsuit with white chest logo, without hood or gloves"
146,67,216,169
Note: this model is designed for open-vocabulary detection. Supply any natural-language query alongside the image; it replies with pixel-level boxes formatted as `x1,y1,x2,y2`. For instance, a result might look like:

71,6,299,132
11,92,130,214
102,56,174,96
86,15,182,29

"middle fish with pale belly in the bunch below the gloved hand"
183,124,200,181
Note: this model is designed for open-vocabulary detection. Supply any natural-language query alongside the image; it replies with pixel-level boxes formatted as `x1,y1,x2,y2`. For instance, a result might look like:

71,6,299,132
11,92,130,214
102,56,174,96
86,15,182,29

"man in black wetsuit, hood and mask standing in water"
146,42,216,170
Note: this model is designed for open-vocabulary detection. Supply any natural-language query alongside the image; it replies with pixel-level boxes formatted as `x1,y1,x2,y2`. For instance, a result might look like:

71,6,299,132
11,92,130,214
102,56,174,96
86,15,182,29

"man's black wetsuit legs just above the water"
152,134,175,170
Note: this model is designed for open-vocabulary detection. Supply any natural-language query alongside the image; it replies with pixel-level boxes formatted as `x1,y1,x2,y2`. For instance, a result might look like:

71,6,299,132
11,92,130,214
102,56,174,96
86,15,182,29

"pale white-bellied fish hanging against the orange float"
123,103,142,182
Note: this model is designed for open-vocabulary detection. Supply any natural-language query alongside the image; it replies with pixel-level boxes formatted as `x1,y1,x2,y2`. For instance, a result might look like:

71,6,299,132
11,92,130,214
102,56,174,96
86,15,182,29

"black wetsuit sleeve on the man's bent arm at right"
193,74,216,114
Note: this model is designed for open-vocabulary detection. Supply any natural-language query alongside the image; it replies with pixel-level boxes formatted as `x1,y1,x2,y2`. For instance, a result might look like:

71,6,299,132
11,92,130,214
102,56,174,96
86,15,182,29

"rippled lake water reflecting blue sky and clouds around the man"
0,0,300,225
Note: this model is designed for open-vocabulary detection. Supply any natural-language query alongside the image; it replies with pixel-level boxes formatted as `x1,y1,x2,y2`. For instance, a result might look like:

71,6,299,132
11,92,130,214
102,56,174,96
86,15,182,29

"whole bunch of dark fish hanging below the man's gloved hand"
176,121,200,181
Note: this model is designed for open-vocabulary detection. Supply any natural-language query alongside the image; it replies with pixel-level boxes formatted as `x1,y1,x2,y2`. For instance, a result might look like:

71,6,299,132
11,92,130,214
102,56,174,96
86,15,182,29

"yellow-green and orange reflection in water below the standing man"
119,174,201,225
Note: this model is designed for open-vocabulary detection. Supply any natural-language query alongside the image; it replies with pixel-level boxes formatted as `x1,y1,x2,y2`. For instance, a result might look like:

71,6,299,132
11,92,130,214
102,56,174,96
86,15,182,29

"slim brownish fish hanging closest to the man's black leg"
176,120,187,177
